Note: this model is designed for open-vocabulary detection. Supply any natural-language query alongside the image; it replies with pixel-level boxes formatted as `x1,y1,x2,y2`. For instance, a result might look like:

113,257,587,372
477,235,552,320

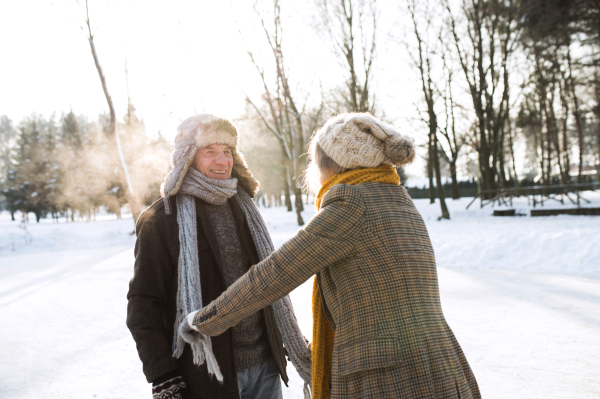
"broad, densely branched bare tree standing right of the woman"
443,0,519,197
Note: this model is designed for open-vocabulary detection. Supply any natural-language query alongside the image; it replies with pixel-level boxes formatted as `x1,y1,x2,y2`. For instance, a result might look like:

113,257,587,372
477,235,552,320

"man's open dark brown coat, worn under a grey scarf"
127,197,288,398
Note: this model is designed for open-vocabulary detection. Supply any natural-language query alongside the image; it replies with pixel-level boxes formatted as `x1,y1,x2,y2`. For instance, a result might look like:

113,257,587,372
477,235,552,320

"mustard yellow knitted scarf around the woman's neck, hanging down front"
312,165,400,399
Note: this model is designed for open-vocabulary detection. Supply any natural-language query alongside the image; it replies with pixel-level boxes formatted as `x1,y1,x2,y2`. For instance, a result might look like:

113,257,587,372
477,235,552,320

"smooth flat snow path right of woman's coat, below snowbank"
439,268,600,399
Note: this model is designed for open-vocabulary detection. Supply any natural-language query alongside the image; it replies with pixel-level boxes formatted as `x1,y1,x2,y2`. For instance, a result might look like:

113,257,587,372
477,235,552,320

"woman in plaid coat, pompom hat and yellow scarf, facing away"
180,113,480,398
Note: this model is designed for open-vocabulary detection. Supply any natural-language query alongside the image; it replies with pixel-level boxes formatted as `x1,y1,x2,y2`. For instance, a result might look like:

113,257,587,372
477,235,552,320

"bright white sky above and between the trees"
0,0,436,175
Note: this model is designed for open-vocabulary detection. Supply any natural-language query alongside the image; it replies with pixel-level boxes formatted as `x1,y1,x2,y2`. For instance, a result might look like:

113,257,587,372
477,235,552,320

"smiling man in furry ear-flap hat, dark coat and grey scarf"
127,114,311,399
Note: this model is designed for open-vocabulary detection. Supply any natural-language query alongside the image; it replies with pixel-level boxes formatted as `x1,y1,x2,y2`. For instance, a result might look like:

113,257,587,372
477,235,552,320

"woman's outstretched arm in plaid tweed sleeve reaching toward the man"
190,185,365,336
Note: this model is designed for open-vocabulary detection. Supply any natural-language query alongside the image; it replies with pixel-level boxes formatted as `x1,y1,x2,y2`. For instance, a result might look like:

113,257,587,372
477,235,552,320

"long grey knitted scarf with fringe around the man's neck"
173,168,312,397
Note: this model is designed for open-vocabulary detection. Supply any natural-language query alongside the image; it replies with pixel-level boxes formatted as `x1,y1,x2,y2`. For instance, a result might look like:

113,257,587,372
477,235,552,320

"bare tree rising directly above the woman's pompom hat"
316,0,377,113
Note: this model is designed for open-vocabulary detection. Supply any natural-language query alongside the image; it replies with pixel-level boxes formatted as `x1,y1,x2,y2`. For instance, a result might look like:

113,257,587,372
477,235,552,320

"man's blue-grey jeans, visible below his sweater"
237,358,283,399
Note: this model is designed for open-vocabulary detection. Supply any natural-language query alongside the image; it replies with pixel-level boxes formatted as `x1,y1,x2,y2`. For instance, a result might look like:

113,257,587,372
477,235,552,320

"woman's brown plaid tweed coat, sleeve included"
194,183,481,398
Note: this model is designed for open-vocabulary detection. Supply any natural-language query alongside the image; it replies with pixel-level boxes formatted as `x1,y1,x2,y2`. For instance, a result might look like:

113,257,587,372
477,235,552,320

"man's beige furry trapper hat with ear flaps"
160,114,260,213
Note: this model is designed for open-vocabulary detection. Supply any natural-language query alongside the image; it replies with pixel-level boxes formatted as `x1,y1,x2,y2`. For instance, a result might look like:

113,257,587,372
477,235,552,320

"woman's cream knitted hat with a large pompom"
311,113,416,169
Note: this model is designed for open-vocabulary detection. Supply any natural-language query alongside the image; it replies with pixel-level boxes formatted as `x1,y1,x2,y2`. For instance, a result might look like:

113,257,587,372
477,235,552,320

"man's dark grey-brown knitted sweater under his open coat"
207,203,271,371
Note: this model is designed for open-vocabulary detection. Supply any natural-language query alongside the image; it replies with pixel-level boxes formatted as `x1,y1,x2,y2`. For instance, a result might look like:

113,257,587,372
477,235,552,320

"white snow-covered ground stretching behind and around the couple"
0,193,600,399
